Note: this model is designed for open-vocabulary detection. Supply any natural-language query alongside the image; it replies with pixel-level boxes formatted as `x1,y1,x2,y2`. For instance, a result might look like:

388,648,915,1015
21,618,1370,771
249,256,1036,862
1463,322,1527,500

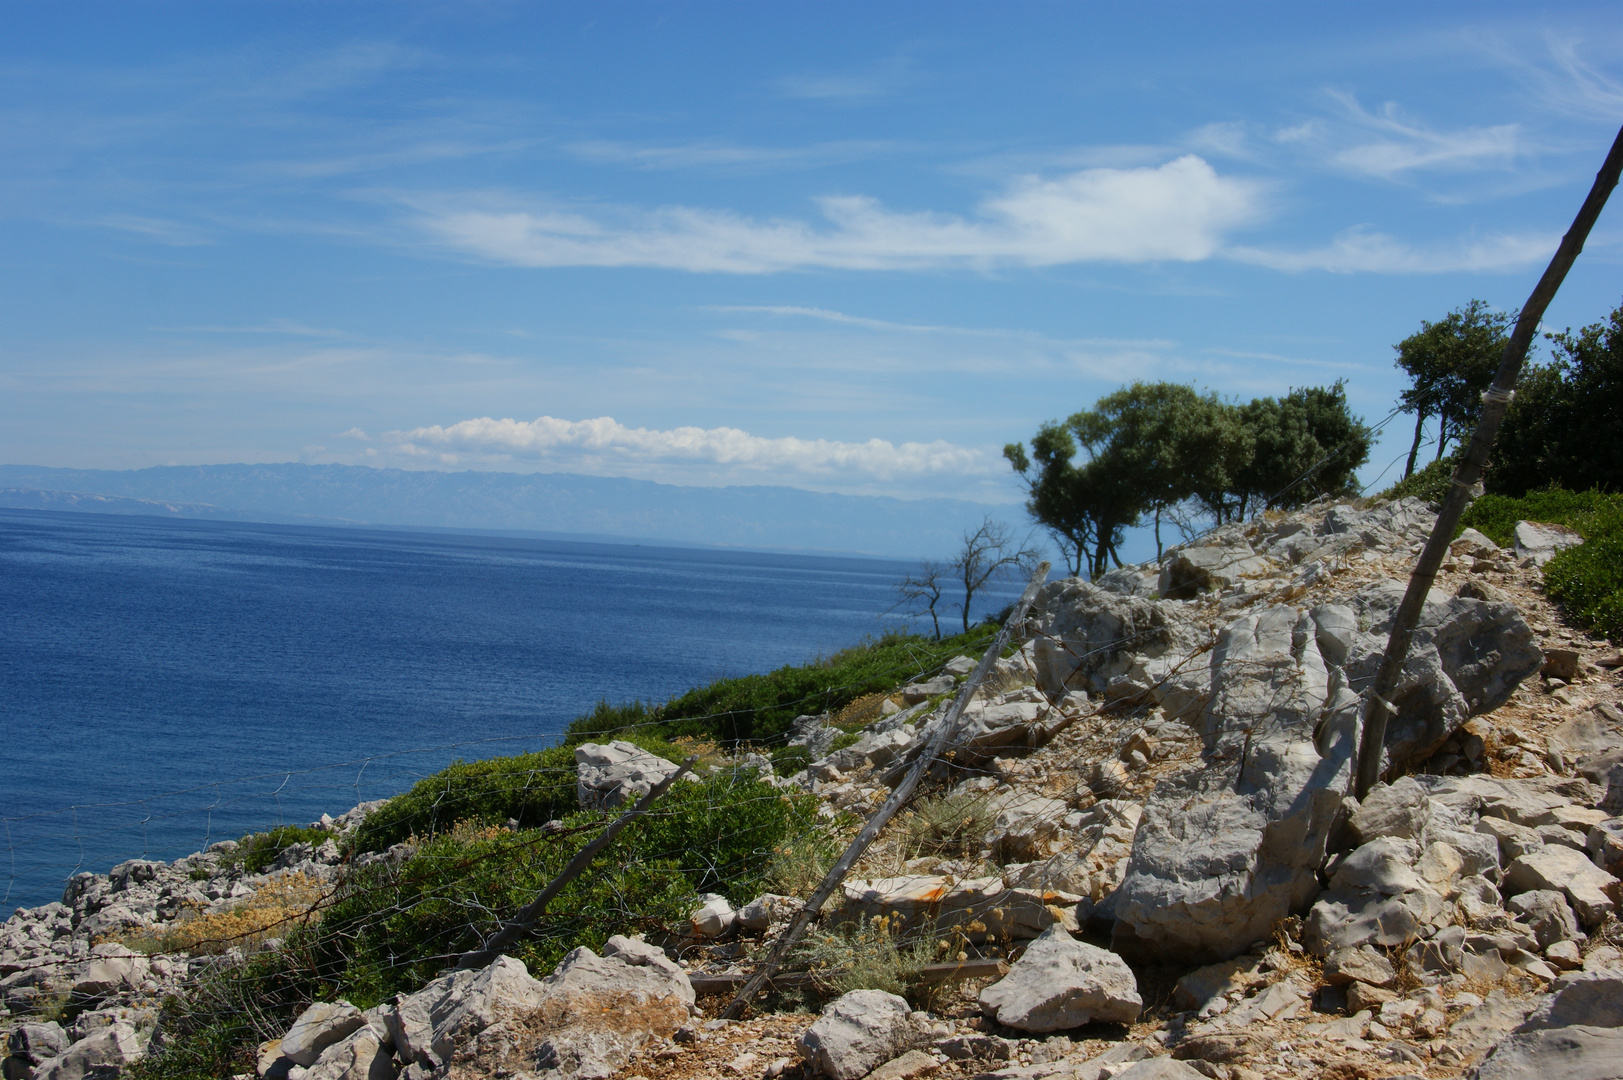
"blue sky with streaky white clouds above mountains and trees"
0,3,1623,502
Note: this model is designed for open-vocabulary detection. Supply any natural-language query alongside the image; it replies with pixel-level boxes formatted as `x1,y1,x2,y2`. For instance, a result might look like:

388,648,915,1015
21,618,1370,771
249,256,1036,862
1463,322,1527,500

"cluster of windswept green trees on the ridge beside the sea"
1003,376,1371,577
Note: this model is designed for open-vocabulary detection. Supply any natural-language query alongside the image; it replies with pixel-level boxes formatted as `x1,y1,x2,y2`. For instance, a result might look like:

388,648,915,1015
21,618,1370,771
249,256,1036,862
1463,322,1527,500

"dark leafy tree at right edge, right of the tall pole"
1487,297,1623,495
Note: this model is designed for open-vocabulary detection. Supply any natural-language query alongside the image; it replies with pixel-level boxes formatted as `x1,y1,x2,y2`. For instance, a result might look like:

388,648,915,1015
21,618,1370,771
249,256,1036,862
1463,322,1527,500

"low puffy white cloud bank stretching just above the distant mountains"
371,416,1001,481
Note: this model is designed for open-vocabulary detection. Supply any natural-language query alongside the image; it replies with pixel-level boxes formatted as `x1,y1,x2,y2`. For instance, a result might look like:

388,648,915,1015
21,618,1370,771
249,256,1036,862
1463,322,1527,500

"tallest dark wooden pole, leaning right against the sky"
1357,130,1623,799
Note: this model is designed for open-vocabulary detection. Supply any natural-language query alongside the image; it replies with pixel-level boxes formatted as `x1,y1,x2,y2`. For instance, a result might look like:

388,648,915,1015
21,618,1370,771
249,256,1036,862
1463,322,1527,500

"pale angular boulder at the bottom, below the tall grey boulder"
980,926,1144,1031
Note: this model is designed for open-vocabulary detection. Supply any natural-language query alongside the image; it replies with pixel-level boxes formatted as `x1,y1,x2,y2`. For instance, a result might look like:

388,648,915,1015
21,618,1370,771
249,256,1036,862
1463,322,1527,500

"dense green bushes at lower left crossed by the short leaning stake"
131,773,834,1080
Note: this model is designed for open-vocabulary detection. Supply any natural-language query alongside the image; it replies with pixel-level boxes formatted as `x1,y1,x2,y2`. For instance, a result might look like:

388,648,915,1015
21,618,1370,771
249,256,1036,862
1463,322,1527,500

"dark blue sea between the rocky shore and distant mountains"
0,510,1008,908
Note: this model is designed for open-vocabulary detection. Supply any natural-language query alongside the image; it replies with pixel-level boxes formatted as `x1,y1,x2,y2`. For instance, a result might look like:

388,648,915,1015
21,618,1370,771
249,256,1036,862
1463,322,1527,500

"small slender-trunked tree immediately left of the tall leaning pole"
1393,300,1514,479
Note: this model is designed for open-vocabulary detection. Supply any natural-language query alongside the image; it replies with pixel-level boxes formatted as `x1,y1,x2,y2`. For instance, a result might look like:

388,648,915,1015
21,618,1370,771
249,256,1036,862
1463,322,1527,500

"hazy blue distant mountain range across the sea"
0,464,1024,559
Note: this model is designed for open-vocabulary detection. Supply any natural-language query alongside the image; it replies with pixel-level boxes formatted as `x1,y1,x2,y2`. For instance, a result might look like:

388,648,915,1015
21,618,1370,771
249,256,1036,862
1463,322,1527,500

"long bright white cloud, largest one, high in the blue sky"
408,154,1263,273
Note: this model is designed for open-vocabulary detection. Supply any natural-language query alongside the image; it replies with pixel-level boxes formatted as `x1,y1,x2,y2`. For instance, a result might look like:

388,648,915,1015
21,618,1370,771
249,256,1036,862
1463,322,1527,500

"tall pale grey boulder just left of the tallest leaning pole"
1115,607,1358,958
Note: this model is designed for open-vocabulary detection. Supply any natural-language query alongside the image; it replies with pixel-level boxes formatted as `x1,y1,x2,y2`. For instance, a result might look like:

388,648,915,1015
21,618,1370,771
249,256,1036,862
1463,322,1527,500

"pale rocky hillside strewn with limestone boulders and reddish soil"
0,500,1623,1080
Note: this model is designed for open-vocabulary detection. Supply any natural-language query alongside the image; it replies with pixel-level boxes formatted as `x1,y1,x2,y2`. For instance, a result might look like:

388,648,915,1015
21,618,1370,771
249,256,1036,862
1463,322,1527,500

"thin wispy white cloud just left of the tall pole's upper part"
1225,227,1560,274
